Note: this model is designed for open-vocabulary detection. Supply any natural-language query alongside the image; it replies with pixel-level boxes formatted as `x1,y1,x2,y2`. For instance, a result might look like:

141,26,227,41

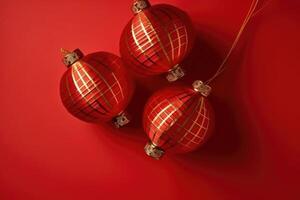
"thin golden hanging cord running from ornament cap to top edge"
205,0,271,84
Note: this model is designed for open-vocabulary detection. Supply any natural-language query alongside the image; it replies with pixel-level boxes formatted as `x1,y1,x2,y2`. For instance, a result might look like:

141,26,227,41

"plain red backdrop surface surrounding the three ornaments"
0,0,300,200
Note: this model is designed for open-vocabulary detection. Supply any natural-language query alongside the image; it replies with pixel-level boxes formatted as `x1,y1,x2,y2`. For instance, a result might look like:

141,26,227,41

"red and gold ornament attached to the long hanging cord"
143,81,214,159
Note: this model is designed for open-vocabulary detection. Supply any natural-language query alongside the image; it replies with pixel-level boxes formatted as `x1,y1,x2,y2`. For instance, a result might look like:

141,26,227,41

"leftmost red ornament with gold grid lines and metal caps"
60,49,133,127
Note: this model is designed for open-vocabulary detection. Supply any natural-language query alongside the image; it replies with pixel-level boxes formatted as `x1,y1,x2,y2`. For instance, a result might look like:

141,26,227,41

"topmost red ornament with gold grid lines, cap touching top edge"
120,0,195,81
